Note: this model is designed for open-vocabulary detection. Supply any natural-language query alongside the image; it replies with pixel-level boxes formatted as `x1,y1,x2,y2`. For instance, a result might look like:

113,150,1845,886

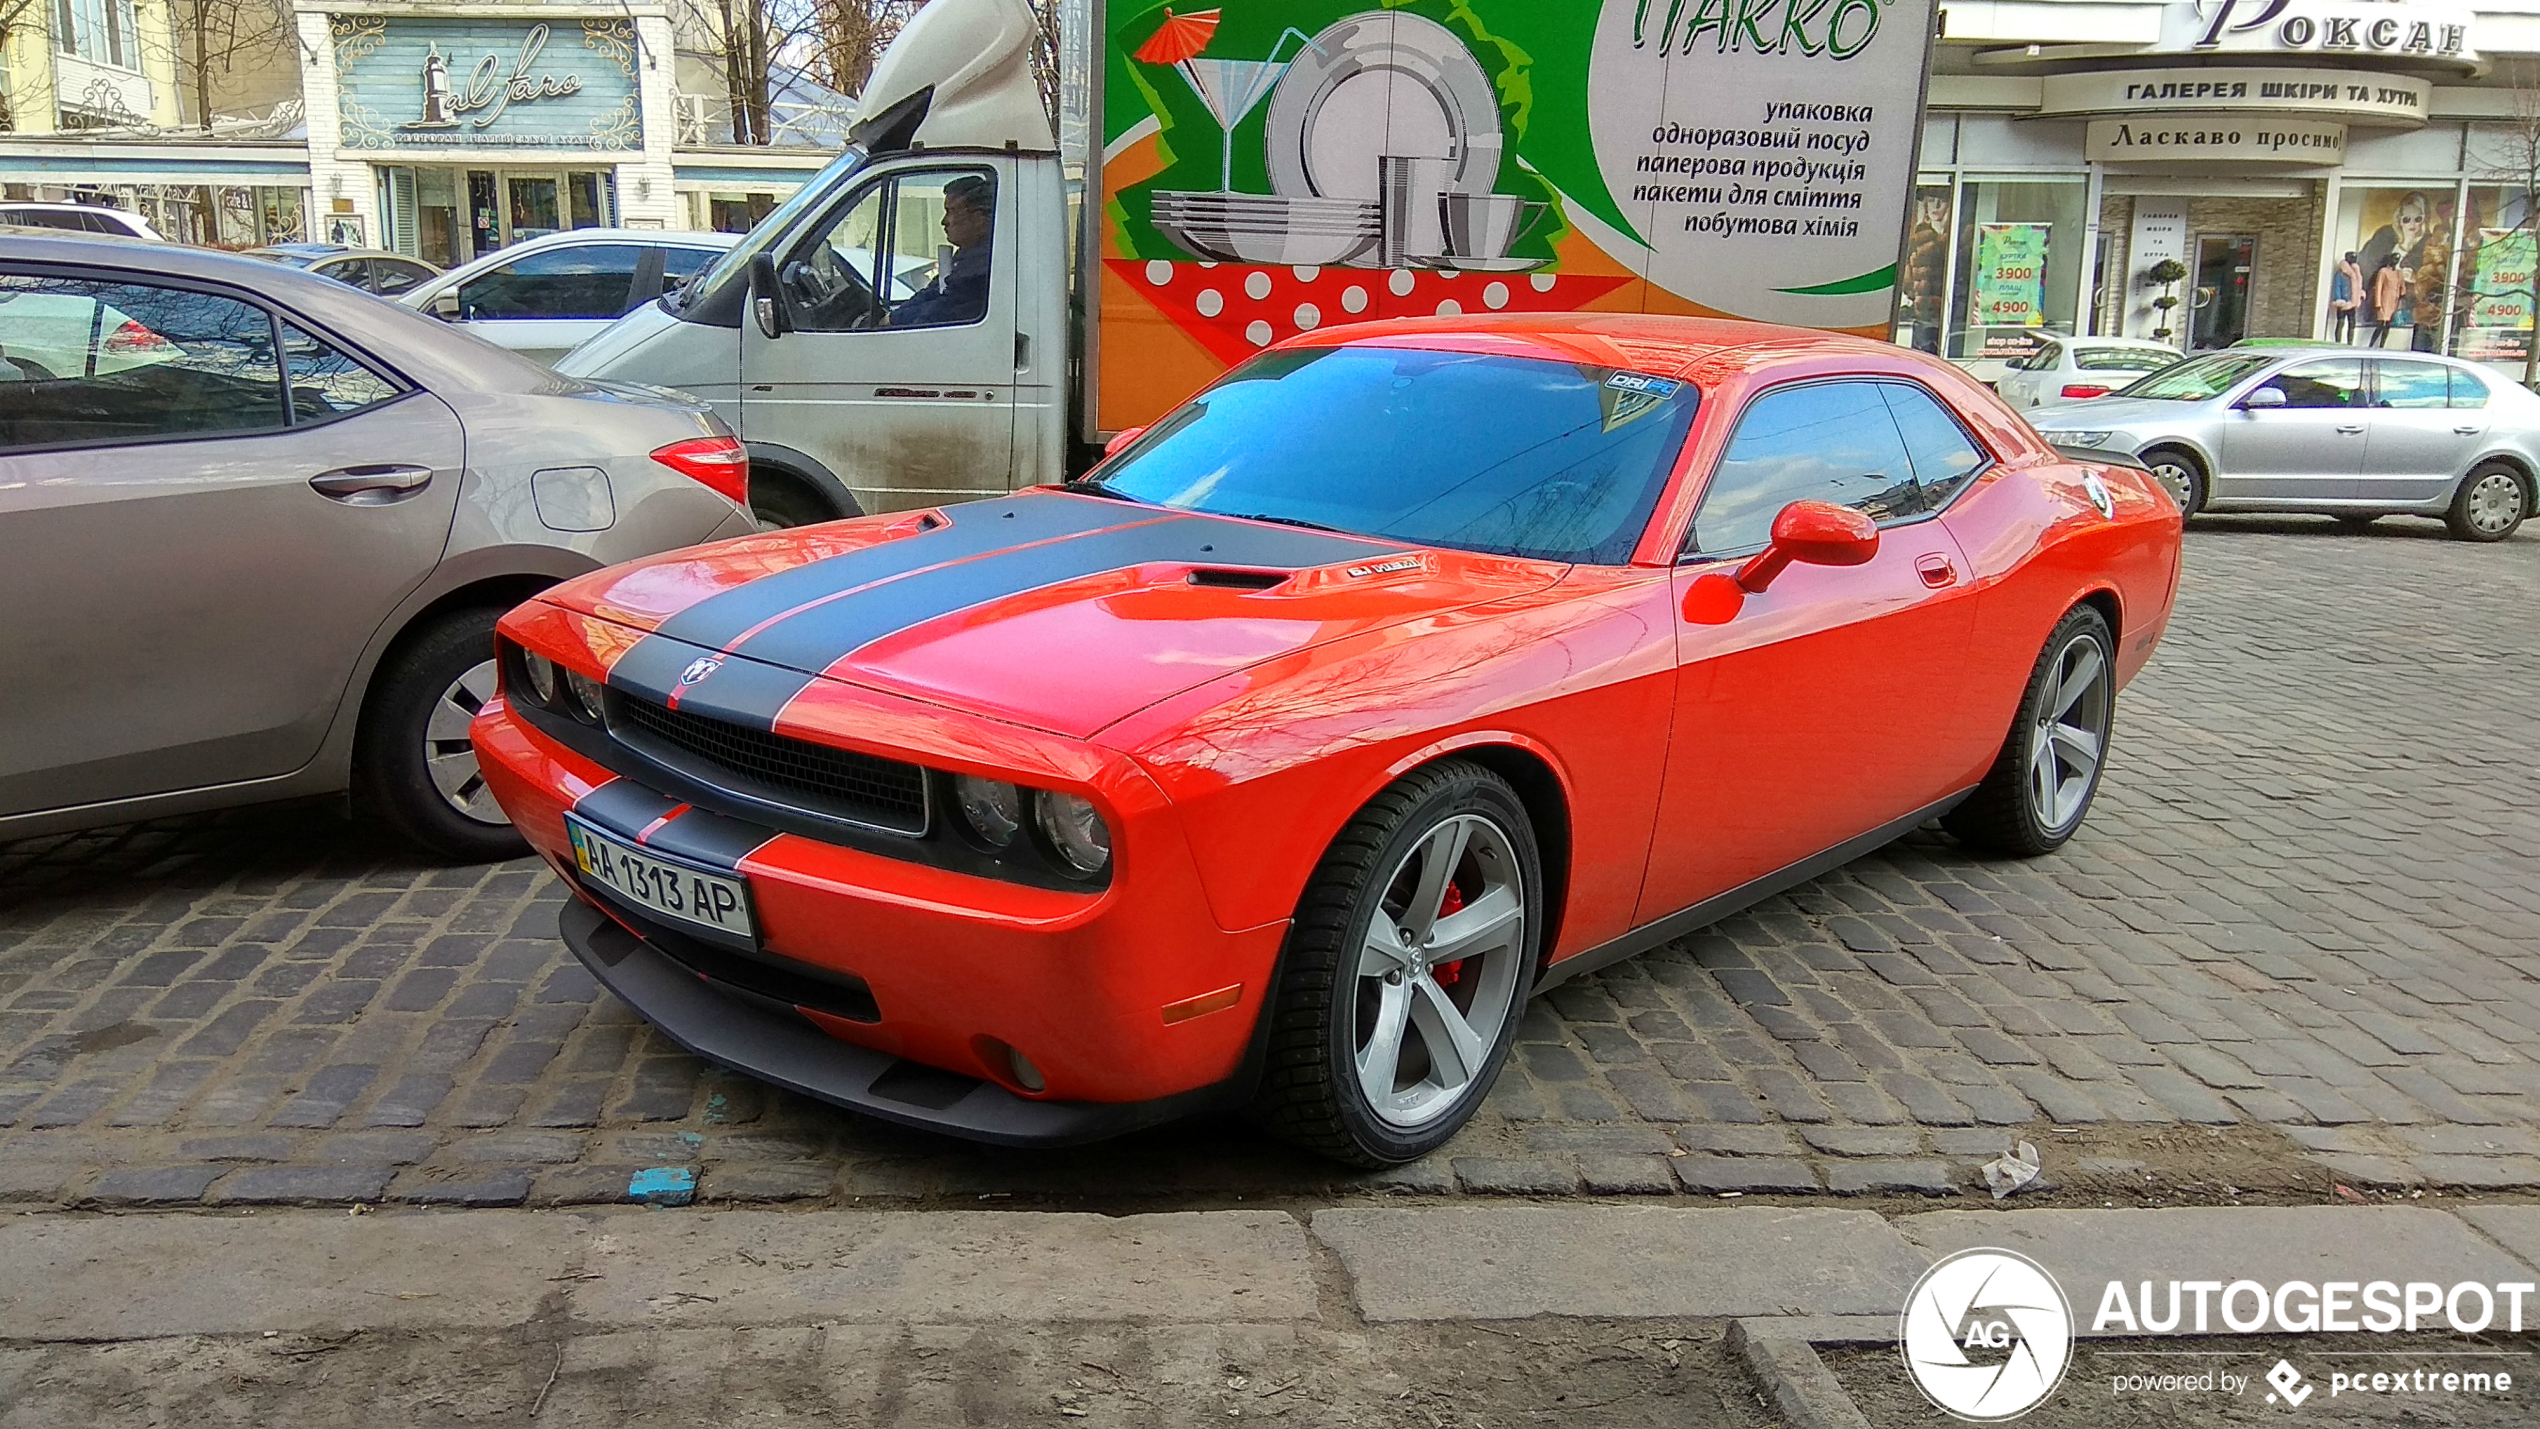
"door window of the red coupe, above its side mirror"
1687,383,1923,556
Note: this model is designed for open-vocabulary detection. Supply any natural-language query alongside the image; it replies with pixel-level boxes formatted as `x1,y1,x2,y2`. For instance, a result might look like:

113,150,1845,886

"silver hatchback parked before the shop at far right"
2029,348,2540,541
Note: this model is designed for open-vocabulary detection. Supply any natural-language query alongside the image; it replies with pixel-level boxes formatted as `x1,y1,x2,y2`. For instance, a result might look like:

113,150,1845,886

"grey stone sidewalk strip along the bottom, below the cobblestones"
0,1206,2540,1426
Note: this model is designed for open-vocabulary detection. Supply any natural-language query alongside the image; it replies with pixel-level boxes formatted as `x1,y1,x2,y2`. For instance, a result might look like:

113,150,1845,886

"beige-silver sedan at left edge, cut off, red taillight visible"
0,236,752,858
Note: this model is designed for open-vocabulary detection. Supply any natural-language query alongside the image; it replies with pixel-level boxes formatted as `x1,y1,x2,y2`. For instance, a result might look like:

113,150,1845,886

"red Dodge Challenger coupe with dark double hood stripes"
472,315,2179,1165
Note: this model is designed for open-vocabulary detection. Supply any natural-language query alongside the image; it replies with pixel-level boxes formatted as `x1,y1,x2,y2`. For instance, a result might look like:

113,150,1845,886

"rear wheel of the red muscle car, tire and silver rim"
1941,604,2116,858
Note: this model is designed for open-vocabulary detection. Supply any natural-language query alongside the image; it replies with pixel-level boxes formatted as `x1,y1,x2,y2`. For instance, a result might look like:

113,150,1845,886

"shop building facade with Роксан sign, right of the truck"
1897,0,2540,376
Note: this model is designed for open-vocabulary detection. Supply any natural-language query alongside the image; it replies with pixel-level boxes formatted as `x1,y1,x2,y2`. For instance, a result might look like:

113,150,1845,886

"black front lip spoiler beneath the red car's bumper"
559,901,1245,1147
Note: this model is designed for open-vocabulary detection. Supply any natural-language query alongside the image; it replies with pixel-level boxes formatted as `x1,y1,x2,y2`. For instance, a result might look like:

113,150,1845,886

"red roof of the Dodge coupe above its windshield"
1280,312,1905,376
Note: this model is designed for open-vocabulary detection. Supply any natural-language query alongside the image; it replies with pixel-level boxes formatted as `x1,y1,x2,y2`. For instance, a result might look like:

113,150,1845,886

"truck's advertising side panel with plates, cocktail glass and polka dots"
1095,0,1933,429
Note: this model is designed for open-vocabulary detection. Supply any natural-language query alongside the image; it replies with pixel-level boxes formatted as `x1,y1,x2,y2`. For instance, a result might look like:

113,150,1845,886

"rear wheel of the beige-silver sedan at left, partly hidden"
353,607,528,863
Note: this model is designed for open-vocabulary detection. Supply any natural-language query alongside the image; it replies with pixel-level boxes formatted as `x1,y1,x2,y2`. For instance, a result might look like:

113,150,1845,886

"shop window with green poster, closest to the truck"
1948,175,2088,360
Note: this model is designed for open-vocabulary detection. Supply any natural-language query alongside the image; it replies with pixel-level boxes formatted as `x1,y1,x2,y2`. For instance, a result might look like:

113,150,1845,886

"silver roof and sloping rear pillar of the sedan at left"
0,234,574,391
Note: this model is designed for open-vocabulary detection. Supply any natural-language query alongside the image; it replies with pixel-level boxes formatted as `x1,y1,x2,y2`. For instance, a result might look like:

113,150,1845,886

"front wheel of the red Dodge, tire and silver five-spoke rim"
1252,759,1544,1168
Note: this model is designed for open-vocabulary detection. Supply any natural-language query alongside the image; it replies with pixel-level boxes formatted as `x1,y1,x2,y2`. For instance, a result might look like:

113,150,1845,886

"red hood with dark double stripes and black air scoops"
544,490,1567,739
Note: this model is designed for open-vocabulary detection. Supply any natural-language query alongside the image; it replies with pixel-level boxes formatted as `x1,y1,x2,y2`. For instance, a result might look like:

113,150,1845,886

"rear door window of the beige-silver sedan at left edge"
0,274,287,449
